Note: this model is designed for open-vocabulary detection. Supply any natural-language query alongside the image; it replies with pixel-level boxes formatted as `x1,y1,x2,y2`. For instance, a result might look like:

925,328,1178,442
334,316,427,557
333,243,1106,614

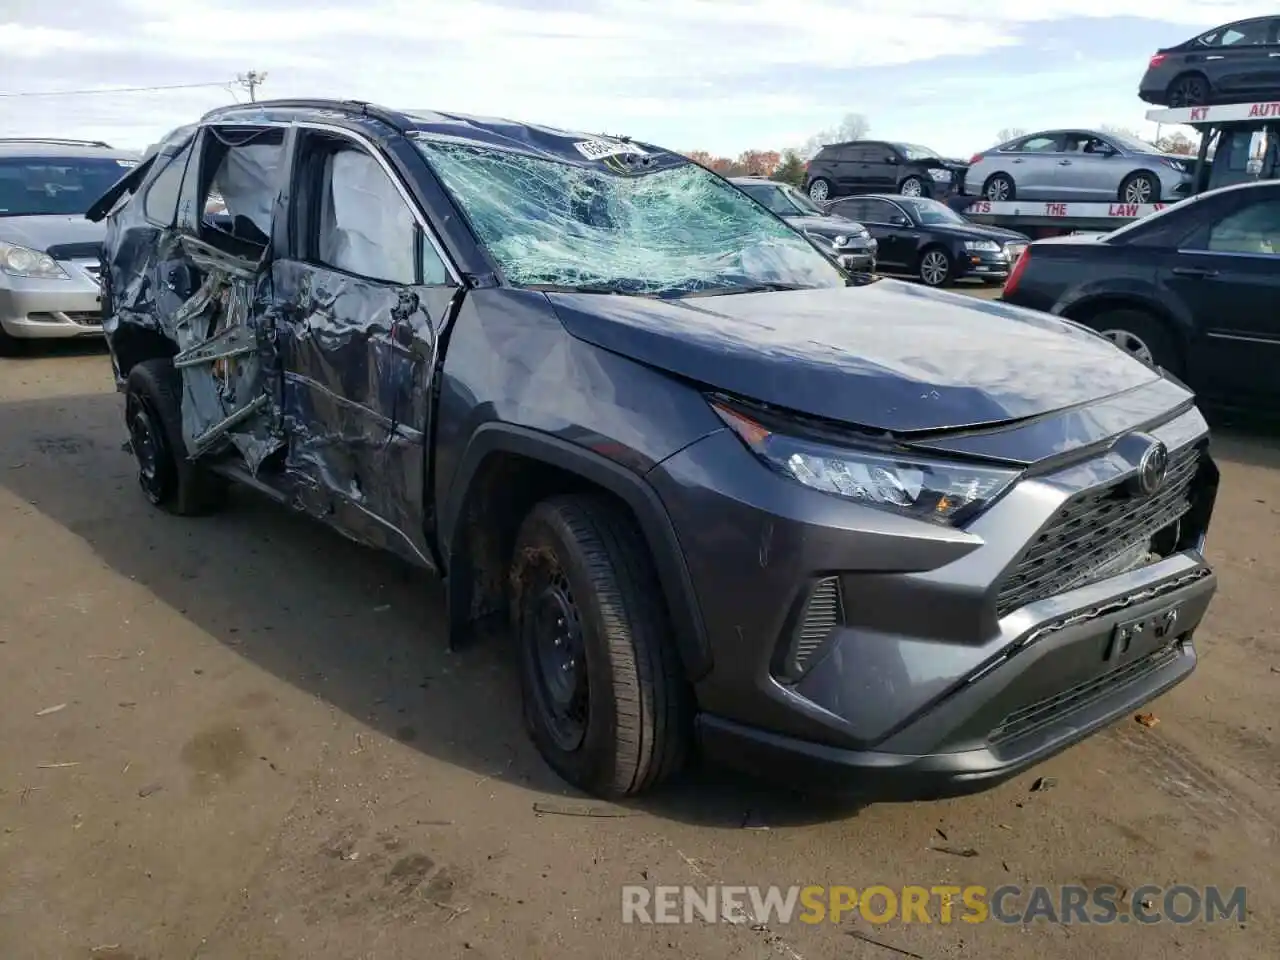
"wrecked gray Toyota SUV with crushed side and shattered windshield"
90,101,1217,797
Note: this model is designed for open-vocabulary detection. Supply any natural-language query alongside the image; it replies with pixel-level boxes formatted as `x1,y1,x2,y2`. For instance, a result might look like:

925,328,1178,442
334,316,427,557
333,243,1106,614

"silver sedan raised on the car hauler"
965,131,1196,204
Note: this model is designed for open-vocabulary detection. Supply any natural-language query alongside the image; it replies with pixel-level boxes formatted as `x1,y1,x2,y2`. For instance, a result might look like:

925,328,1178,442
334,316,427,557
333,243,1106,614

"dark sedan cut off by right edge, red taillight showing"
1004,180,1280,407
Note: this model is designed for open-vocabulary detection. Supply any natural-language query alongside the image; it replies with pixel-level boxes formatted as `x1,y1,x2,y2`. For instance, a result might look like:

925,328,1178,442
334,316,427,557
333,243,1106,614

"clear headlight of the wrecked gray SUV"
712,399,1018,525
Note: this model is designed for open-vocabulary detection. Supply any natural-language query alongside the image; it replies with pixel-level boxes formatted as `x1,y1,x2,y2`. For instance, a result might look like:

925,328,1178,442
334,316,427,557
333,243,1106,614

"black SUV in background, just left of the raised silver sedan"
804,140,965,204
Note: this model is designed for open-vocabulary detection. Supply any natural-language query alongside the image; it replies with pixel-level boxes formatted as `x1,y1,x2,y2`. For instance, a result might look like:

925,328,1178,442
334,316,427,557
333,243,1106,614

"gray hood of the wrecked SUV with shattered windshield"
547,280,1160,433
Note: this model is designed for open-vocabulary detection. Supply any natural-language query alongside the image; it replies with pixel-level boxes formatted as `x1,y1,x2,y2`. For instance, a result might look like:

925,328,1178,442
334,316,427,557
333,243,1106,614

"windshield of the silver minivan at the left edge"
0,156,137,216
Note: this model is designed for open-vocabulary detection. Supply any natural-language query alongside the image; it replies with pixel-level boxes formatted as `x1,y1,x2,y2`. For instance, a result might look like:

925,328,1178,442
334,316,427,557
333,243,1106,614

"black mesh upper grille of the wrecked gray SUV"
996,447,1201,617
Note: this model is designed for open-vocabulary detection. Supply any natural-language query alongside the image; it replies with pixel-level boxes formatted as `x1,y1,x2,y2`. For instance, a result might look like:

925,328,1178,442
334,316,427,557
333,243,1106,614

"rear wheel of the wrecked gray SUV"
124,358,228,516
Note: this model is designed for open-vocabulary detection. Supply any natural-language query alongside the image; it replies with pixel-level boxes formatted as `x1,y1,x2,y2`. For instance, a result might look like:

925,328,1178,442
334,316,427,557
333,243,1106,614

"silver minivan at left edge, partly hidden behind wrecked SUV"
0,138,137,355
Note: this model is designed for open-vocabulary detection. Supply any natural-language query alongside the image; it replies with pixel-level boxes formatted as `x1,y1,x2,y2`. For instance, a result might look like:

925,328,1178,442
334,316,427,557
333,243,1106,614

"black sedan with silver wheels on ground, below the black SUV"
827,195,1030,287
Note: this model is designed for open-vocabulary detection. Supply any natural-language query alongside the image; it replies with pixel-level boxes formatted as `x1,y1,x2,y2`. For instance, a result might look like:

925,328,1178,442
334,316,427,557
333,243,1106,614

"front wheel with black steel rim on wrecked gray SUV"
511,495,690,799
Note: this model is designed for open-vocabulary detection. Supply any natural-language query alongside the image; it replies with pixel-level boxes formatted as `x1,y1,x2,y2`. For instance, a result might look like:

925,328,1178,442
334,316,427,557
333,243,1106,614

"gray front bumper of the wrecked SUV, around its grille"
649,410,1216,797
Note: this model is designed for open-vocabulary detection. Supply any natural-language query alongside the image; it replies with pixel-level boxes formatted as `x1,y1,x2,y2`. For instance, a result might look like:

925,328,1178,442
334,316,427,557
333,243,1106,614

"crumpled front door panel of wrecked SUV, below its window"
273,261,443,566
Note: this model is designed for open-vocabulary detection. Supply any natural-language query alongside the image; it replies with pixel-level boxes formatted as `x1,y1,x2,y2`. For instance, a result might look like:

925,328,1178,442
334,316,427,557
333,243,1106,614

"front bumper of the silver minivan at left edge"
0,260,102,339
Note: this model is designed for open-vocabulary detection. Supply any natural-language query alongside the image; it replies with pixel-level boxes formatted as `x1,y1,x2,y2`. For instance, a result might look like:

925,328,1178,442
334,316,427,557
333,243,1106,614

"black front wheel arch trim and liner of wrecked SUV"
439,422,712,682
